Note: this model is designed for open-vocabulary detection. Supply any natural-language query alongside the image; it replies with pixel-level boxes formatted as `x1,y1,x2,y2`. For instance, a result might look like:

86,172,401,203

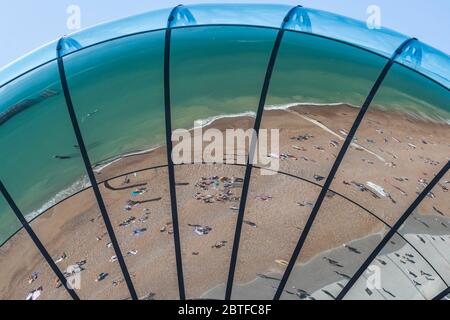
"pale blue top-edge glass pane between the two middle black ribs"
186,3,292,28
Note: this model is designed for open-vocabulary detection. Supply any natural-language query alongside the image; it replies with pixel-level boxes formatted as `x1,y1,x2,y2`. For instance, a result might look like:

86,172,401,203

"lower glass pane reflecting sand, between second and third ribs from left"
100,168,179,300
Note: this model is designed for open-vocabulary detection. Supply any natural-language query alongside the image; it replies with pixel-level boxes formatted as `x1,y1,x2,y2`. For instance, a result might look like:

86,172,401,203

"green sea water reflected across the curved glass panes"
0,27,450,243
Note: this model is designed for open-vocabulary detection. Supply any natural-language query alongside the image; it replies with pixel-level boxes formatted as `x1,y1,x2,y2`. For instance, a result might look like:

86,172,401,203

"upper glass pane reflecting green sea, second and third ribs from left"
64,31,167,181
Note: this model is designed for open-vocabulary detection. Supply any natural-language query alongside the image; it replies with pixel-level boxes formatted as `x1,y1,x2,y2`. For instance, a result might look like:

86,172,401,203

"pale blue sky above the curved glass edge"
0,0,450,68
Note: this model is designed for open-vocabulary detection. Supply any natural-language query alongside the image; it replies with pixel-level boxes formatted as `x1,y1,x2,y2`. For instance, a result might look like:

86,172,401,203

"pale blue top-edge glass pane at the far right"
396,41,450,88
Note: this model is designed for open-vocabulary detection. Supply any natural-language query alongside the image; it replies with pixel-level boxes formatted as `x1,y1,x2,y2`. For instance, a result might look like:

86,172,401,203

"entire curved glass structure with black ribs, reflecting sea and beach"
0,4,450,300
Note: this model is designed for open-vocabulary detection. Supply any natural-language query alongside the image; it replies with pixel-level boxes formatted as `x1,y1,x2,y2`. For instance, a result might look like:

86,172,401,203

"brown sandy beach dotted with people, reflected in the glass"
0,105,450,300
